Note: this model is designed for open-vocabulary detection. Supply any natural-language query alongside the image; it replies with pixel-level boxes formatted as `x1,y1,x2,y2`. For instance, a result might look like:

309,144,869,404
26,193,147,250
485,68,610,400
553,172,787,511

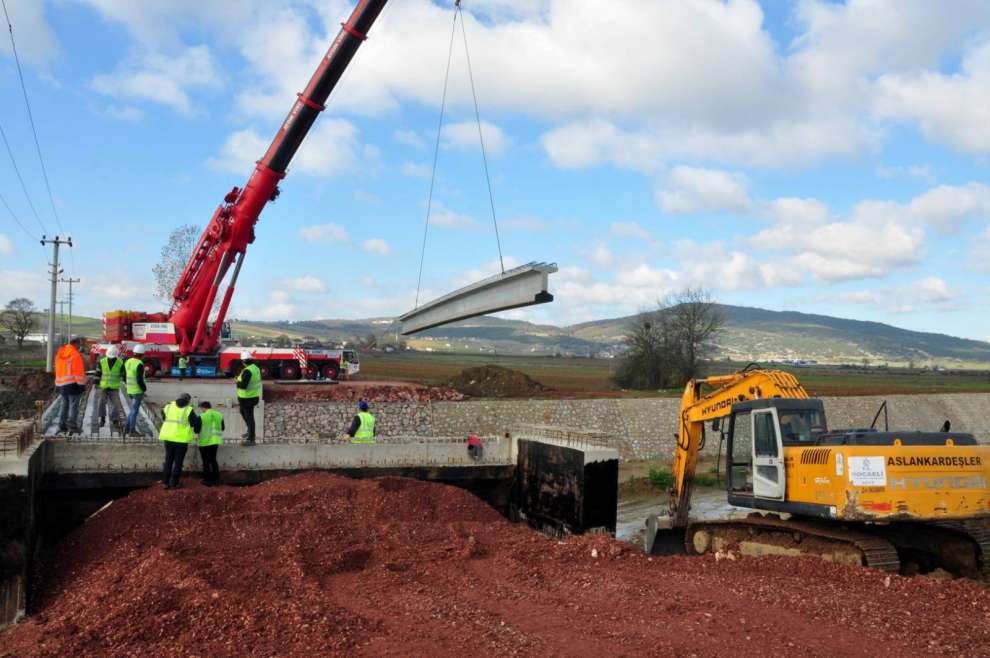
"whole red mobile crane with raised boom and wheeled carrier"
90,0,387,379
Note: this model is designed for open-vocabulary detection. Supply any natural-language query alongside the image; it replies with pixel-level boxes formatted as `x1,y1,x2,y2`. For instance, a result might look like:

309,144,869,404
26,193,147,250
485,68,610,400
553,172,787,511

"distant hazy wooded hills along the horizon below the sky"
227,305,990,366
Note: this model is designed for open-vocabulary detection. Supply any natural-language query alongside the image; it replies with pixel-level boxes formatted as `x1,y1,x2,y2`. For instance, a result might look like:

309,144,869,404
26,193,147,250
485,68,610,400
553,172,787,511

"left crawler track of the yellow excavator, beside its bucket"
684,514,904,573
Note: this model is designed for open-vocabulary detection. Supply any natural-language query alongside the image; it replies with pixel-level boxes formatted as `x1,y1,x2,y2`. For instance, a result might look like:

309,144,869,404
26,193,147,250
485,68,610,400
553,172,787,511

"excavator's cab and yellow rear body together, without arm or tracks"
717,398,990,521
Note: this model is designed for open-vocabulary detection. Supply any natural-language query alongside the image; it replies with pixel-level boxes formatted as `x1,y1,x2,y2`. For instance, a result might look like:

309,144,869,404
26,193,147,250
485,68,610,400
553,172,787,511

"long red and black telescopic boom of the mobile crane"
169,0,387,354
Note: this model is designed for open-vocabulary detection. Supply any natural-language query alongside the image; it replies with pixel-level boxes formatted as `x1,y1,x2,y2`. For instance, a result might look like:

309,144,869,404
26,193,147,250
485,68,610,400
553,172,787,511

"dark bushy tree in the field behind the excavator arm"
615,288,725,389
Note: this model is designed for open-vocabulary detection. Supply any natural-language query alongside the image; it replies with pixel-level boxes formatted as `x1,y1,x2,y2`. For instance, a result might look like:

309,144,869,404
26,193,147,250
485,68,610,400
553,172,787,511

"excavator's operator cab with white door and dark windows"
721,398,828,507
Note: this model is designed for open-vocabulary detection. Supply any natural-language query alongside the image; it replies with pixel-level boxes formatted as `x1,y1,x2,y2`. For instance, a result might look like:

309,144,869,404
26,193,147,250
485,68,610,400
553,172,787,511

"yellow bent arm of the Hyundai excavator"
668,369,809,528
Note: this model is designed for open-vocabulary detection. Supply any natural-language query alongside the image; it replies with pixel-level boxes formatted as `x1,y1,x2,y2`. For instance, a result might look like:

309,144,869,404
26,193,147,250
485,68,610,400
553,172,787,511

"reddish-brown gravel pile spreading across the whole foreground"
0,473,990,657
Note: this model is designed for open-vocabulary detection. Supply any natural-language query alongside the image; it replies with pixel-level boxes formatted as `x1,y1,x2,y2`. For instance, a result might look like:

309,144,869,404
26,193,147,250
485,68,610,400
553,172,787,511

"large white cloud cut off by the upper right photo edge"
874,39,990,153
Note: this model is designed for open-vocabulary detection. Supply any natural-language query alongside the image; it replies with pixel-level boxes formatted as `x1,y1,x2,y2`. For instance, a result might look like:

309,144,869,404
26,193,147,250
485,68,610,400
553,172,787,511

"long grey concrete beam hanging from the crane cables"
399,263,557,336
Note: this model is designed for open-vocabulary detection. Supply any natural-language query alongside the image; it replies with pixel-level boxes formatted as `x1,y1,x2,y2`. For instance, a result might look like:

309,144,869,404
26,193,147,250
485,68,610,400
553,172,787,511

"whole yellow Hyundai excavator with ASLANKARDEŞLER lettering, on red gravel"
646,366,990,577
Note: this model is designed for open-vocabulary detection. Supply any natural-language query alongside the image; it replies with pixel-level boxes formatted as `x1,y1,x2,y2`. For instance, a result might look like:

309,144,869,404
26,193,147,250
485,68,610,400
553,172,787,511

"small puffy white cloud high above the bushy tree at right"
657,166,751,213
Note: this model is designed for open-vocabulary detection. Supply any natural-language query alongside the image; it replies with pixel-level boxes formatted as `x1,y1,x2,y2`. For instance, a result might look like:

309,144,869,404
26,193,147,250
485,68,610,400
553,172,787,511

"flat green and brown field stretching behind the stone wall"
360,352,990,397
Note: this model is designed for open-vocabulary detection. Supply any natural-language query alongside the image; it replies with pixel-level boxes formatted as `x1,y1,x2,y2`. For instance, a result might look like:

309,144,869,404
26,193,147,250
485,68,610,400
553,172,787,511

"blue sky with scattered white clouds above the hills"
0,0,990,339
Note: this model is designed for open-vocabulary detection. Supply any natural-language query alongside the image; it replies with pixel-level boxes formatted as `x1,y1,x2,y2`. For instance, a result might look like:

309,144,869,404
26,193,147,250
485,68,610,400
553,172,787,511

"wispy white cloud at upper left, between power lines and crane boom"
91,45,221,115
